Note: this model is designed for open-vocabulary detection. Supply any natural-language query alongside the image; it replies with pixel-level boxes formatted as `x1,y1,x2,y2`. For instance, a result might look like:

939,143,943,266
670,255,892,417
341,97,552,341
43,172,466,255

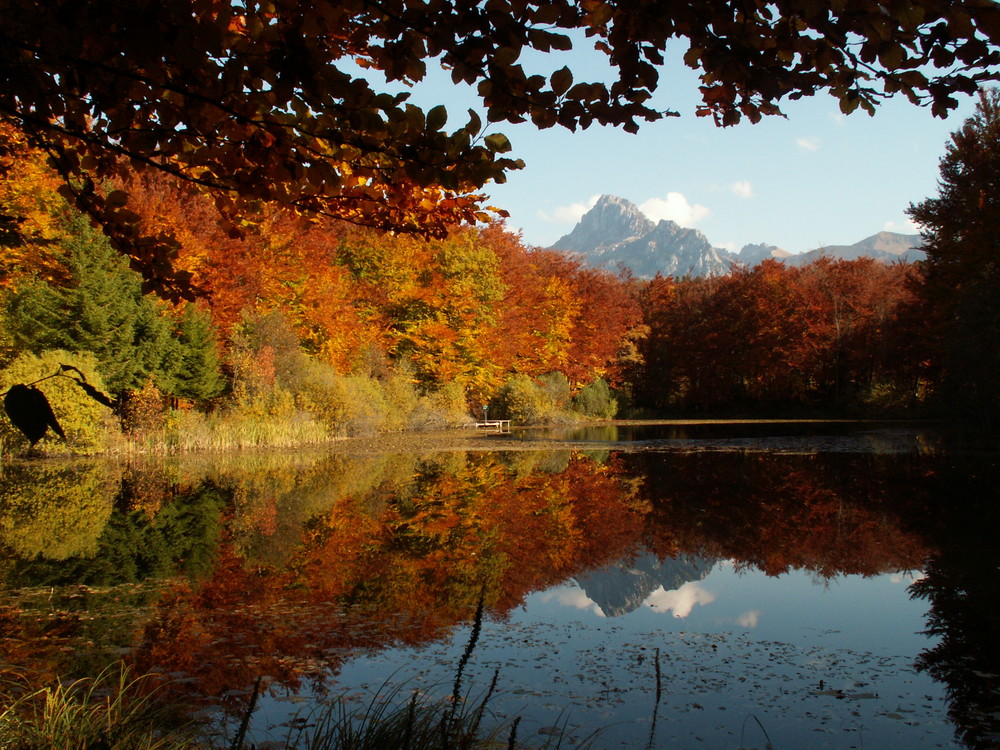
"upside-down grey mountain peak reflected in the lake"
576,553,716,617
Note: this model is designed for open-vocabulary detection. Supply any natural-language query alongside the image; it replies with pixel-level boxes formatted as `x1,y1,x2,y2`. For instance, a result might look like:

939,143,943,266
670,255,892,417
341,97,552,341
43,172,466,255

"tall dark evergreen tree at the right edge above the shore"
909,89,1000,424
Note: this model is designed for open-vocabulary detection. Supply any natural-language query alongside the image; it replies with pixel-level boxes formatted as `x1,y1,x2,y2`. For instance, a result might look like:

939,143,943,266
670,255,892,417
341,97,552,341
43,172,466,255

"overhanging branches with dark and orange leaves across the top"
0,0,1000,295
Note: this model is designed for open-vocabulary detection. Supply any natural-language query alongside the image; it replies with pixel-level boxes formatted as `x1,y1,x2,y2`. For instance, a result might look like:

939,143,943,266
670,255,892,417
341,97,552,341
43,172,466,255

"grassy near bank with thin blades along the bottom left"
0,665,591,750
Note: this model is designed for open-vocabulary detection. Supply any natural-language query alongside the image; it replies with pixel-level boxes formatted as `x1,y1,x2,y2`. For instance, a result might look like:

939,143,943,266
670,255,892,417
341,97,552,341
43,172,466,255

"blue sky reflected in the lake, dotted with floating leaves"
246,563,958,750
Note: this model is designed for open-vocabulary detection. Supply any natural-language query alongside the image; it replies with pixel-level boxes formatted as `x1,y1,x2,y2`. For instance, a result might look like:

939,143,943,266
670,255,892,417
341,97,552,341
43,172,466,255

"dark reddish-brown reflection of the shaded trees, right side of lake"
629,453,927,577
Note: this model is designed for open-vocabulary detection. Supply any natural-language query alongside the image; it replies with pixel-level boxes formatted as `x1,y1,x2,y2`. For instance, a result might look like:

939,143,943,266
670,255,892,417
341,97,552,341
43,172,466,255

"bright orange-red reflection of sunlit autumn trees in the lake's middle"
131,454,644,712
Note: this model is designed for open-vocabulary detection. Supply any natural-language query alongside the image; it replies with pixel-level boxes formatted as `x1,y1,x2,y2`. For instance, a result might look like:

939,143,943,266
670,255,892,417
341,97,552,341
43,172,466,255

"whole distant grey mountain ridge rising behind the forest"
549,195,924,278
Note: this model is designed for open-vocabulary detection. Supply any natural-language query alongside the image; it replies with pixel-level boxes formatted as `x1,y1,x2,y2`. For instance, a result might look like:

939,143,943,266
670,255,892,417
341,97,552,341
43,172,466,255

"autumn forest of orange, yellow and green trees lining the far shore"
0,122,932,452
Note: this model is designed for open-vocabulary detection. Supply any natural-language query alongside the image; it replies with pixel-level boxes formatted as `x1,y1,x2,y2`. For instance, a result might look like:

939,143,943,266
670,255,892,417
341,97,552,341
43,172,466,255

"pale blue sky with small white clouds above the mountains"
398,45,975,253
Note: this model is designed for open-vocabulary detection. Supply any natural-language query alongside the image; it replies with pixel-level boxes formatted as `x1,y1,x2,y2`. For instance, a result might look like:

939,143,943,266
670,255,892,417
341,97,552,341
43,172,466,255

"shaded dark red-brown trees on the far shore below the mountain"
636,259,925,409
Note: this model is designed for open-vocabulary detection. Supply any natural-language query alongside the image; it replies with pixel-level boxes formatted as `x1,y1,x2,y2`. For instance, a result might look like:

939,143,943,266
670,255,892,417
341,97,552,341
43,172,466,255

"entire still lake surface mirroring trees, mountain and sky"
0,423,1000,749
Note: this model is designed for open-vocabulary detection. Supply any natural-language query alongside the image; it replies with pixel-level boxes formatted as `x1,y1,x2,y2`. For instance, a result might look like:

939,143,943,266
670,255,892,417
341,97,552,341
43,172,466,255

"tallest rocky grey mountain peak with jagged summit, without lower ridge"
550,195,730,278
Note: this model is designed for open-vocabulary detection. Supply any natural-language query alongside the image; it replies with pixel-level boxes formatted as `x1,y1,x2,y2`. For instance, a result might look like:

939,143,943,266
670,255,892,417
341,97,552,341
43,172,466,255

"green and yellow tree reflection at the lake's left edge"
0,478,225,682
